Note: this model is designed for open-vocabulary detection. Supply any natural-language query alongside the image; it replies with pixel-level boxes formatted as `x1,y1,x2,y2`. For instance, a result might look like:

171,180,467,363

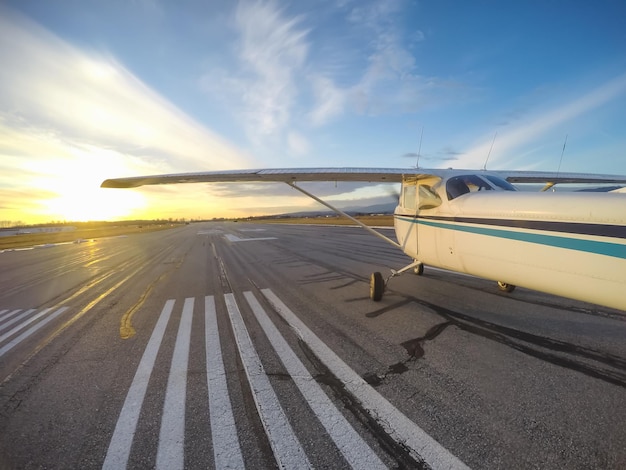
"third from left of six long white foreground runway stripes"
204,295,245,470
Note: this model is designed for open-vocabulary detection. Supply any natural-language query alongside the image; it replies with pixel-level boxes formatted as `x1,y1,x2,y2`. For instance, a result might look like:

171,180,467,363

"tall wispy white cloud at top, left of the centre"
201,1,309,145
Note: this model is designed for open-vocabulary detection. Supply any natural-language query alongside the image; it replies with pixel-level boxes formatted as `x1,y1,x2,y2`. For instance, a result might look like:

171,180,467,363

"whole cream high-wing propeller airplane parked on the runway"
102,168,626,310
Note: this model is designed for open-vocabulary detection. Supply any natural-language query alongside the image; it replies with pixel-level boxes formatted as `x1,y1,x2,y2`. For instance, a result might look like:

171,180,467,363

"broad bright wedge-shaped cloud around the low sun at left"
0,8,249,222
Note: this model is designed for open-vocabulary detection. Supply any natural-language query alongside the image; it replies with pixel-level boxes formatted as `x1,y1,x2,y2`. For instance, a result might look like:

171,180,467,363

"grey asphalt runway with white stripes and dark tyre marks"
0,222,626,469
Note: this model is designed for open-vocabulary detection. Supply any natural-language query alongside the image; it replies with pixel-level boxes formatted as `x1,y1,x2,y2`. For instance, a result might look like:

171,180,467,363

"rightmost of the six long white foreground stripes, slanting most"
262,289,468,469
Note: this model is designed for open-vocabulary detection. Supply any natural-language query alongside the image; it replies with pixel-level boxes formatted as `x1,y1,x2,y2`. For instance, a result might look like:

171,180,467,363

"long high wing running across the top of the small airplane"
101,168,626,188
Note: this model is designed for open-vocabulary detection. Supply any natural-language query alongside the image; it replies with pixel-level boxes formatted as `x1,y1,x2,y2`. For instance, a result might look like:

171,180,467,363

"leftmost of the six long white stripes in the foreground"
102,299,174,470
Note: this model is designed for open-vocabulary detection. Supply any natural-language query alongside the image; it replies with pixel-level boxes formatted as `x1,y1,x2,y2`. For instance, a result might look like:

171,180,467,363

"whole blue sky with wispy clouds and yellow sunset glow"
0,0,626,226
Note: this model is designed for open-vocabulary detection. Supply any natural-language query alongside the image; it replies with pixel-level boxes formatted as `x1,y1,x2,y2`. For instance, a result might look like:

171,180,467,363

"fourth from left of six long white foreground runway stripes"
224,294,311,469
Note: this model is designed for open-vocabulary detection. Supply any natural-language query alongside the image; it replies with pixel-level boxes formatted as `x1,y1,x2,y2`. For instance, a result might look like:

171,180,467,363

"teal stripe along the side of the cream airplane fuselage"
396,216,626,259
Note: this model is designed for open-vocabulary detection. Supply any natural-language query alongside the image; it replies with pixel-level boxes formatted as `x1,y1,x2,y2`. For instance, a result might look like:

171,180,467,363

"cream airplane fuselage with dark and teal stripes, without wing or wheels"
395,175,626,310
